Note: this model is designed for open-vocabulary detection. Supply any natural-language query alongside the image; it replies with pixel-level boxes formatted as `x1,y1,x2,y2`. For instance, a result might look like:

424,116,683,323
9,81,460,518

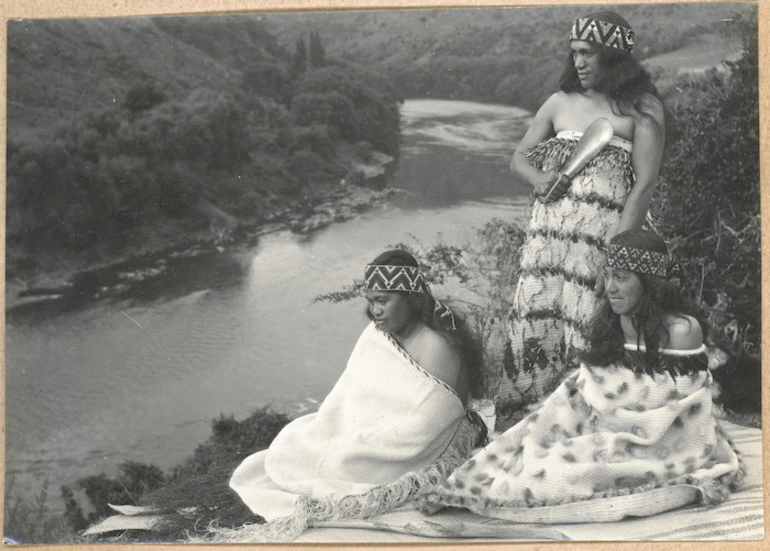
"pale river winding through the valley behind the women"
6,100,529,504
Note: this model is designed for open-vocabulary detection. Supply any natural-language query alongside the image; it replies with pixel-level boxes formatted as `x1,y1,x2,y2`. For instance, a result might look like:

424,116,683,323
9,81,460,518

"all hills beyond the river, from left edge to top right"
7,3,755,280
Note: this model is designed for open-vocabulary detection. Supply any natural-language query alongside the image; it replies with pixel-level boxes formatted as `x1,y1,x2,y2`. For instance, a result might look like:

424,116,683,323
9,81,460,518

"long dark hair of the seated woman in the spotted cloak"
580,229,708,374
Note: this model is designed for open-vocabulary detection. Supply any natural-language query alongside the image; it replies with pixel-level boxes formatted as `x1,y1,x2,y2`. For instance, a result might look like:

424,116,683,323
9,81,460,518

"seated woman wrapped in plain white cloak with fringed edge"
230,251,482,541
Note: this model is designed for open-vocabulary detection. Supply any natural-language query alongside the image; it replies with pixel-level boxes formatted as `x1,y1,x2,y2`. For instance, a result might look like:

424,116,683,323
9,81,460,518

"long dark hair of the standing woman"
559,11,668,123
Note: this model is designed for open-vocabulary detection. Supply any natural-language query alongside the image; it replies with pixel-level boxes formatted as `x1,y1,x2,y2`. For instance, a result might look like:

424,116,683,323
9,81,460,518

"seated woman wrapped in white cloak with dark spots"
422,229,743,523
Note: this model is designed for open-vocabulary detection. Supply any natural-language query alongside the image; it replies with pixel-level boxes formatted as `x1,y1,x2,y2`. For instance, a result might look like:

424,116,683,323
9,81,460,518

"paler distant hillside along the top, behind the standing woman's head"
265,3,752,108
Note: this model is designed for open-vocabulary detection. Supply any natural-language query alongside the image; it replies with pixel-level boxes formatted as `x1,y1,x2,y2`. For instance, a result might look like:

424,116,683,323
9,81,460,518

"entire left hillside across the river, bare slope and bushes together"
7,16,399,277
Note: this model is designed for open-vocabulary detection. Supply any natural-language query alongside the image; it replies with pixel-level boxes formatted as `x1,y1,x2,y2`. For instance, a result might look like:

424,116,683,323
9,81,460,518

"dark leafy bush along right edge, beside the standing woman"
654,11,761,353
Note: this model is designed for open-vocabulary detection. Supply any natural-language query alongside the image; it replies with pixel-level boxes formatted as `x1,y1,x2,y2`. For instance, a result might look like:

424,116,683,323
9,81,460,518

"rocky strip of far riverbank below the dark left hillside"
5,152,399,312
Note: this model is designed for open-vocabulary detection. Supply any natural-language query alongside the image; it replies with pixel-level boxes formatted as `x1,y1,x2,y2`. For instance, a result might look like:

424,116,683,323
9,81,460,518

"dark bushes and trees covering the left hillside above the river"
7,17,399,276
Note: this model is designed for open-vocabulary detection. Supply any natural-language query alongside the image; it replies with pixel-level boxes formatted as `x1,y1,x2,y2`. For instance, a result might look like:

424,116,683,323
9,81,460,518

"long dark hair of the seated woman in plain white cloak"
366,249,484,398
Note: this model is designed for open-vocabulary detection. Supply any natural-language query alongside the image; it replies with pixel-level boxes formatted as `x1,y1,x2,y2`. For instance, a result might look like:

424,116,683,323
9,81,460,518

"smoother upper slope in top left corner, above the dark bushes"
8,17,280,139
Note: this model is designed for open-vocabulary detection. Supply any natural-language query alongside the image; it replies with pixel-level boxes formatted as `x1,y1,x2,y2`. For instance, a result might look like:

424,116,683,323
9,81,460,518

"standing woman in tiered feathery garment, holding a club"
497,11,665,428
